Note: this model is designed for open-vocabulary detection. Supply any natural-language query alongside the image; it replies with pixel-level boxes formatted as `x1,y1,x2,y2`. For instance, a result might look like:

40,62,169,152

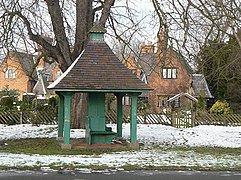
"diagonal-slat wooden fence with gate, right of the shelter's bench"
106,110,241,128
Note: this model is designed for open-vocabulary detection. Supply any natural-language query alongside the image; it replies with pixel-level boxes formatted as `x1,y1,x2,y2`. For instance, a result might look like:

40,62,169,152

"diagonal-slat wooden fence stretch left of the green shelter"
0,110,57,125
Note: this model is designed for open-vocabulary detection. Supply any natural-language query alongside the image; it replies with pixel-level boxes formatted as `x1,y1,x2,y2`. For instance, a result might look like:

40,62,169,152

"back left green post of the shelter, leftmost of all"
58,93,64,137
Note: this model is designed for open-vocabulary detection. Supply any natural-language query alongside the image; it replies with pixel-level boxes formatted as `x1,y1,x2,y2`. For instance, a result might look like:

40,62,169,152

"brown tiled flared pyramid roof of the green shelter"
48,27,151,92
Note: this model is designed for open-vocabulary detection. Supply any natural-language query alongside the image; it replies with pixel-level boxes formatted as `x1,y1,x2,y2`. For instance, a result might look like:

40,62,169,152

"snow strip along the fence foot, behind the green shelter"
0,124,241,148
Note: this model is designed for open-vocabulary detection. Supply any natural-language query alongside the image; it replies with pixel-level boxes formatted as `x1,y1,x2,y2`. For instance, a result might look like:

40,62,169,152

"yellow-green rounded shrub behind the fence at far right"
210,100,233,114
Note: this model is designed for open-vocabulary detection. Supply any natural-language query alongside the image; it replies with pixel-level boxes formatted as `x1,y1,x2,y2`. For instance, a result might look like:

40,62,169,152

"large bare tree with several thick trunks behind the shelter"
0,0,151,127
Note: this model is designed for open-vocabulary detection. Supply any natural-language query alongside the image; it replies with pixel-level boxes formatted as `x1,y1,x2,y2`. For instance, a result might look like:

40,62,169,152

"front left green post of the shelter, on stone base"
63,93,72,144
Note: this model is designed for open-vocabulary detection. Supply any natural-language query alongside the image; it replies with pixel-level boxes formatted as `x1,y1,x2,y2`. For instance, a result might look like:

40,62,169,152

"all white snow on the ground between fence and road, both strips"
0,124,241,168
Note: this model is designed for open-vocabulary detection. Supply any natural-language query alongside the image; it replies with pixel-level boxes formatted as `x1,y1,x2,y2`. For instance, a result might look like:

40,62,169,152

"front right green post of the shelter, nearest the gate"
130,93,138,144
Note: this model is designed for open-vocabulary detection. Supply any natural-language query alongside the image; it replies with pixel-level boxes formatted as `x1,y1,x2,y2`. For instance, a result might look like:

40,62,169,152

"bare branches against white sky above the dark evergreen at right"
152,0,241,66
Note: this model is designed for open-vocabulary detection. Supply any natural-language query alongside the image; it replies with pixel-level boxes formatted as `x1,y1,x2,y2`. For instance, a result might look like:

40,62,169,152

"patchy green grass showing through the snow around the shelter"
0,138,241,170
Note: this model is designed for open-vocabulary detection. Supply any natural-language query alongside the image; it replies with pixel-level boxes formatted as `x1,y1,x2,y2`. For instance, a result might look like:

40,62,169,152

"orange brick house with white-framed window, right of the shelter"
126,28,213,112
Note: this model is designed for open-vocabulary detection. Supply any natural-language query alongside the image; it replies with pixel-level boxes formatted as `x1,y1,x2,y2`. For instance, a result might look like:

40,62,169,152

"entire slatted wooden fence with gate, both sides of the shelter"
0,110,241,127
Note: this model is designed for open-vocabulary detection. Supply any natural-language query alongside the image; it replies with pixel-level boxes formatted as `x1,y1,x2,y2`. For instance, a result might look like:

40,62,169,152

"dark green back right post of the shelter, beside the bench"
117,94,123,137
